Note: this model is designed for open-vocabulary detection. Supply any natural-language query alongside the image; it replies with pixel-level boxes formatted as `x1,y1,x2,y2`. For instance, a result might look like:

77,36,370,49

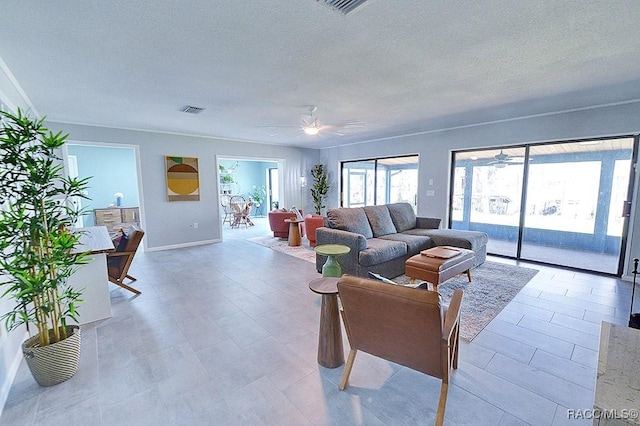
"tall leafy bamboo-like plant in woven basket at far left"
0,111,89,386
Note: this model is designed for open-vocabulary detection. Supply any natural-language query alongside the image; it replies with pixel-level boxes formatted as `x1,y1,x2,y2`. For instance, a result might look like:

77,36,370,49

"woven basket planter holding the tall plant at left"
22,326,81,386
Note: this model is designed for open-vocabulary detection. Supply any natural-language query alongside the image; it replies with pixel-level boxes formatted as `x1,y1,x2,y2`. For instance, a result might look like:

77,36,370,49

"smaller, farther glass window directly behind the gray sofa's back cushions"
341,155,418,210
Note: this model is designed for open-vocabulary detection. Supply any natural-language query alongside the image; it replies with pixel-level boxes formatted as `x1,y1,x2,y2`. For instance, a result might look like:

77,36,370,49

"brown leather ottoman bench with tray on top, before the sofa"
405,246,475,291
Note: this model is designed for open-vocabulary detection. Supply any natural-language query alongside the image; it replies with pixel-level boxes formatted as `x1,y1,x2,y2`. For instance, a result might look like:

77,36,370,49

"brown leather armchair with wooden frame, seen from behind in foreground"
338,275,462,425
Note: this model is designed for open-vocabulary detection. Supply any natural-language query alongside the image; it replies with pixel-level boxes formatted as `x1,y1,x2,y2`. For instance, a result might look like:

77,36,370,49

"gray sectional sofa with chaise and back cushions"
316,203,488,278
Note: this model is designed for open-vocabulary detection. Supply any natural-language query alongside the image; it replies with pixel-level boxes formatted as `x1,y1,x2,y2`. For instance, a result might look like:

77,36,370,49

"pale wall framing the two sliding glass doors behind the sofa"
321,100,640,279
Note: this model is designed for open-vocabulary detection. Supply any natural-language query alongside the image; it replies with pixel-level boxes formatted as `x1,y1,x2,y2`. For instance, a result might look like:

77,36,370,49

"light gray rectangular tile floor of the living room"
0,219,631,425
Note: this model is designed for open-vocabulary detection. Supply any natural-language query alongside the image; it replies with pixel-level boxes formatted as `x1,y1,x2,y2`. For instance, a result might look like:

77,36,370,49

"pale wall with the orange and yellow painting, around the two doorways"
46,123,319,250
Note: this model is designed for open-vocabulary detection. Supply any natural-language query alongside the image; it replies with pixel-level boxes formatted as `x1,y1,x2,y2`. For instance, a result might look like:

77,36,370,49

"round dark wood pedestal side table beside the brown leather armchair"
309,277,344,368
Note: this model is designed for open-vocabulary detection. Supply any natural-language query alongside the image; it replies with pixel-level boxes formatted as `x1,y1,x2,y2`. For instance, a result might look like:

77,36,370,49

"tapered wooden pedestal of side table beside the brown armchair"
318,294,344,368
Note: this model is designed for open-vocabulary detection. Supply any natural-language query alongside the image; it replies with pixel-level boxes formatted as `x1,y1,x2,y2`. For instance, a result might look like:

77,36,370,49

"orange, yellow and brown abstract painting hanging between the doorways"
165,156,200,201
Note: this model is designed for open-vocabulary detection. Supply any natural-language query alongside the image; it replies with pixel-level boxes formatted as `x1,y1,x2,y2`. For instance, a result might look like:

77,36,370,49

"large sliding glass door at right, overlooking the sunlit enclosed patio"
450,137,635,275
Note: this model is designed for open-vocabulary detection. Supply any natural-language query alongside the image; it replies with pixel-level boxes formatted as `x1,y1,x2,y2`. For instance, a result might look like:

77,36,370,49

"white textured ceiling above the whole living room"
0,0,640,148
